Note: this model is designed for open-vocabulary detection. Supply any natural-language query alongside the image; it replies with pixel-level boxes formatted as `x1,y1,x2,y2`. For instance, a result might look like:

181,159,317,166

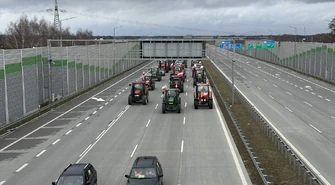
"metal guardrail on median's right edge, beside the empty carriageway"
207,49,331,185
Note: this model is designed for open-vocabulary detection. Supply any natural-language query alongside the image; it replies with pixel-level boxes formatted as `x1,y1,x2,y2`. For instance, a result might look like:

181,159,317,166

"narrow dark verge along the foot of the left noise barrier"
0,61,147,136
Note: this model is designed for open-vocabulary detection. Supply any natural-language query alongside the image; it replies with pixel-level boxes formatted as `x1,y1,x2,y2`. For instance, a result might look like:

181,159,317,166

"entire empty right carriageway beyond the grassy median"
210,47,335,183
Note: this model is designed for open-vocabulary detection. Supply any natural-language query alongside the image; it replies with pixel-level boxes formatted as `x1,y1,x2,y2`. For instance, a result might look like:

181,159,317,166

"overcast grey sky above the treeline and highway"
0,0,335,35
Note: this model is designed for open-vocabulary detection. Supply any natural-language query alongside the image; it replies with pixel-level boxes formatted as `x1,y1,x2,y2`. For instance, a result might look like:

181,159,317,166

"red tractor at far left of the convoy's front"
128,81,149,105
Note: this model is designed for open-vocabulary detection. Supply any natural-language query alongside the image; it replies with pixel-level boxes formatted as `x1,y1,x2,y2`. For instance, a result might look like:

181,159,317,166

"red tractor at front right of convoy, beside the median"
194,83,213,109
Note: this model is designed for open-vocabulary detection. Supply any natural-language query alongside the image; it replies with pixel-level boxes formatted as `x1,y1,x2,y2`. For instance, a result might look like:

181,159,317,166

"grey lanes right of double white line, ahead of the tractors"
81,64,251,185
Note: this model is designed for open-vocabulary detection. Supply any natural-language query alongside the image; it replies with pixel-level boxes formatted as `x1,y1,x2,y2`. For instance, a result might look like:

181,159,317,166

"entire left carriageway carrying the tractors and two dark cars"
0,60,251,185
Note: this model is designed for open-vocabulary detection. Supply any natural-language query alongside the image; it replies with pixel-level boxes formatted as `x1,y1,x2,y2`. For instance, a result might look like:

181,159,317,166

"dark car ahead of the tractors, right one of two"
125,156,163,185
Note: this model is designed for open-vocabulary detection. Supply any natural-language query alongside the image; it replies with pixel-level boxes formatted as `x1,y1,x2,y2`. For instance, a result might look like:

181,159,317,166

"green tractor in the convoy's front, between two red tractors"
162,89,181,114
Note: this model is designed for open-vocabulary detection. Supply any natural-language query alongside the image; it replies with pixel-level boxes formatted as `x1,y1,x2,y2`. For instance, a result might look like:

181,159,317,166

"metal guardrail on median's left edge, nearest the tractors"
205,62,273,185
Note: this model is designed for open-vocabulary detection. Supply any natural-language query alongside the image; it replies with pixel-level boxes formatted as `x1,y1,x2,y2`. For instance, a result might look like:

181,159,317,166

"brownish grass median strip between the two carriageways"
204,60,303,185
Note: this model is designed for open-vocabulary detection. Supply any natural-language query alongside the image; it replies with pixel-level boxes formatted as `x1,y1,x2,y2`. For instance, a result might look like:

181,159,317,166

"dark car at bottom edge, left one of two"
52,163,98,185
